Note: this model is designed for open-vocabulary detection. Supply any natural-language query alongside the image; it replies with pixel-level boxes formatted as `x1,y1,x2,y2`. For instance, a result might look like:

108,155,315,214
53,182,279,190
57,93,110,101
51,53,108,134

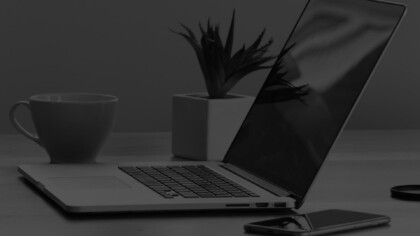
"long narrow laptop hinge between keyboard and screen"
220,163,294,198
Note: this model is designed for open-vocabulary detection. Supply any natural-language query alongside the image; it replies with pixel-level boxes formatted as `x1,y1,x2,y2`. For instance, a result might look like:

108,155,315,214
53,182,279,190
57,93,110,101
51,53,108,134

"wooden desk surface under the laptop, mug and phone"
0,130,420,236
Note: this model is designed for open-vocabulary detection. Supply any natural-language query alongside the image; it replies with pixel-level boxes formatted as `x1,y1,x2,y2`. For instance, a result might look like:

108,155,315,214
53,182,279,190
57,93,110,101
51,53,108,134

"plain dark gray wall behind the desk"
0,0,420,133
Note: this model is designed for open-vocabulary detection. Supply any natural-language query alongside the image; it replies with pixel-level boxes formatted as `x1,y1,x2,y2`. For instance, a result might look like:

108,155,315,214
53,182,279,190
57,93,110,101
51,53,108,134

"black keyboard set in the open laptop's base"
118,165,259,198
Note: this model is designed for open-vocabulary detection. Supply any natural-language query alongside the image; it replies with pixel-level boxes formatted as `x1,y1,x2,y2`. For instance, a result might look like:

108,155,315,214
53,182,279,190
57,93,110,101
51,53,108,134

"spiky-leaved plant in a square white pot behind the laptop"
172,11,275,160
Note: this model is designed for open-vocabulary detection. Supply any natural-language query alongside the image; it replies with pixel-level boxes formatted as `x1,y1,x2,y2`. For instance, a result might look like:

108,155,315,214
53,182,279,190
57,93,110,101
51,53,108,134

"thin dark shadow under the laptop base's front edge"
19,177,296,221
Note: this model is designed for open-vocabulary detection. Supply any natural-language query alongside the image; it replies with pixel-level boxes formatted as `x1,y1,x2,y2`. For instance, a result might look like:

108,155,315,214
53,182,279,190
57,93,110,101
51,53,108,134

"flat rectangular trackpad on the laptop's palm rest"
49,176,130,189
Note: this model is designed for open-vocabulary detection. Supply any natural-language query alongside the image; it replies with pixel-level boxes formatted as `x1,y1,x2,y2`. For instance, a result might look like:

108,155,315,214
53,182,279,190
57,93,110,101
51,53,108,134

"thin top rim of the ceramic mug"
29,93,119,103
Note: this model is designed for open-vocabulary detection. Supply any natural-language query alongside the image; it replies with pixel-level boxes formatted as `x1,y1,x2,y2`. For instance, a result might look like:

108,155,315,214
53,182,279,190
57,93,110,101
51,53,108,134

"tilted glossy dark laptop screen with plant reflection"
224,0,405,203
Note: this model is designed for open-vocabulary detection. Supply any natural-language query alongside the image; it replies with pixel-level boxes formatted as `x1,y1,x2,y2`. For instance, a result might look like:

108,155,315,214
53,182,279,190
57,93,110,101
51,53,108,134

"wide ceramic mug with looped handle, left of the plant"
9,93,118,163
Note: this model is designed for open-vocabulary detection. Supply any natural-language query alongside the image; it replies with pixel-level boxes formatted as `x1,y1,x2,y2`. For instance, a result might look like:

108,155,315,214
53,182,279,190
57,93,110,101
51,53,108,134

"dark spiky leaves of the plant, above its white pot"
173,10,275,98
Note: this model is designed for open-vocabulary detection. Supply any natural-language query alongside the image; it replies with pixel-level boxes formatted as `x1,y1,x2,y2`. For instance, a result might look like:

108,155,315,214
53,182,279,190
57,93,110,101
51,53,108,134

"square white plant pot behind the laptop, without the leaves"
172,93,254,161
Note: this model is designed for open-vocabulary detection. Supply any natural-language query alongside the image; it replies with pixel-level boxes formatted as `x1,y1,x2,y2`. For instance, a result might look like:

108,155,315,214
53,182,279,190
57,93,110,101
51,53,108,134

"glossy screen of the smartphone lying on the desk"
249,210,389,232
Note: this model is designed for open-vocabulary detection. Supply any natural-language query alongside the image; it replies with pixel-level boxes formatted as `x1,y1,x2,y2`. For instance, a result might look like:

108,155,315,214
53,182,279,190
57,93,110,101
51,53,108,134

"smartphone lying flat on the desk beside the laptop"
244,209,391,236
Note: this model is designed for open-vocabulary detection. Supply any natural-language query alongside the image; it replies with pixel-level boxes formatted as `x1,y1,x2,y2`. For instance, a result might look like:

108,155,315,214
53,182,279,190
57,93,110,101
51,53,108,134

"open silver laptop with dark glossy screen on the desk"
18,0,405,212
